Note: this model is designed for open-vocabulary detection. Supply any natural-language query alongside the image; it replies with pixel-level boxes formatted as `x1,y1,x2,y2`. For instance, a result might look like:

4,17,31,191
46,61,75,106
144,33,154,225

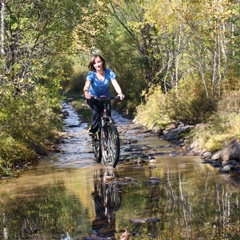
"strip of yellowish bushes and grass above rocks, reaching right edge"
136,88,240,151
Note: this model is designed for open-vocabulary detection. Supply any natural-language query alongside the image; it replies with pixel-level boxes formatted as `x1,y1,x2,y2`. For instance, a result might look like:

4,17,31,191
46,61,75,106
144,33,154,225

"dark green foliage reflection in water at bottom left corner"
0,183,89,239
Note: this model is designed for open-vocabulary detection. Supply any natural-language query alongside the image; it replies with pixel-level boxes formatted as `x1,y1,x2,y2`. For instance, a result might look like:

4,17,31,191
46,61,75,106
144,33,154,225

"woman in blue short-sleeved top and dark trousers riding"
83,54,124,135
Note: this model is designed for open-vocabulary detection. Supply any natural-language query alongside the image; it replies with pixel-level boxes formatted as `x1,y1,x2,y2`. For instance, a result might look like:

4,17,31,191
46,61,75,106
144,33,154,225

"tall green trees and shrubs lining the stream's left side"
0,0,81,174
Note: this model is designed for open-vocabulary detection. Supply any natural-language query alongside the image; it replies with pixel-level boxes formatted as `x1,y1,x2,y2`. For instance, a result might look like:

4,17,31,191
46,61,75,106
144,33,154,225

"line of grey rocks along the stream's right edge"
148,123,240,174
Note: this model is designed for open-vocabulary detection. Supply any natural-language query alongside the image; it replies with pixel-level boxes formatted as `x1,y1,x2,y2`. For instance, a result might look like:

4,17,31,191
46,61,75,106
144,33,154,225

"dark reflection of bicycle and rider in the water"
83,168,122,240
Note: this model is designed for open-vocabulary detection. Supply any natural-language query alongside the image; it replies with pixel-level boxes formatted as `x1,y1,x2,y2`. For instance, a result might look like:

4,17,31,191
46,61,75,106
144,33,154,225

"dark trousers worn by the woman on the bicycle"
87,98,111,133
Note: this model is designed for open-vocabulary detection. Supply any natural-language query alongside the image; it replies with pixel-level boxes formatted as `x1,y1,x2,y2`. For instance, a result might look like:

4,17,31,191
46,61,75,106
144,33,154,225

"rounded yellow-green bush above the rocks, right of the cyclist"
137,75,216,128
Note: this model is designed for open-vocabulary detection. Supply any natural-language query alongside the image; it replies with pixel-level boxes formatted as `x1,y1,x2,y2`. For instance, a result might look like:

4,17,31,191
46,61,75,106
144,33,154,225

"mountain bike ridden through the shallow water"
82,96,120,168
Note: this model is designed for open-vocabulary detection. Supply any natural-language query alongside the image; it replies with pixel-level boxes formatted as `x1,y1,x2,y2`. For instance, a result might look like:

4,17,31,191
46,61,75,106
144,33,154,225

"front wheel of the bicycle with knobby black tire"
100,123,120,168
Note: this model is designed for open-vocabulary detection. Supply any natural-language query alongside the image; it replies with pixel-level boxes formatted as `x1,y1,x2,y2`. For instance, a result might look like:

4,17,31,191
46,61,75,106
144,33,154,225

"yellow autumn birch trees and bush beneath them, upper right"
104,0,239,147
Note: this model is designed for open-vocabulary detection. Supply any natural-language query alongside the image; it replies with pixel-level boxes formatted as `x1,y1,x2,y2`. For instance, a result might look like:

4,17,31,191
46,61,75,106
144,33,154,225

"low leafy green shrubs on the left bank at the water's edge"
0,86,61,174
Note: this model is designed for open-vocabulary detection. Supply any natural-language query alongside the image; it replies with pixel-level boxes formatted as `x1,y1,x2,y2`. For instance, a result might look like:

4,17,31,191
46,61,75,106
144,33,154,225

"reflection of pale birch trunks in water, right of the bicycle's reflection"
118,166,240,239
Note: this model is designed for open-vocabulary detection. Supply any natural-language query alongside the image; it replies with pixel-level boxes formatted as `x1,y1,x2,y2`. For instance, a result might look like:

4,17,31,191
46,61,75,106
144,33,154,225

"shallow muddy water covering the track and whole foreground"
0,104,240,240
